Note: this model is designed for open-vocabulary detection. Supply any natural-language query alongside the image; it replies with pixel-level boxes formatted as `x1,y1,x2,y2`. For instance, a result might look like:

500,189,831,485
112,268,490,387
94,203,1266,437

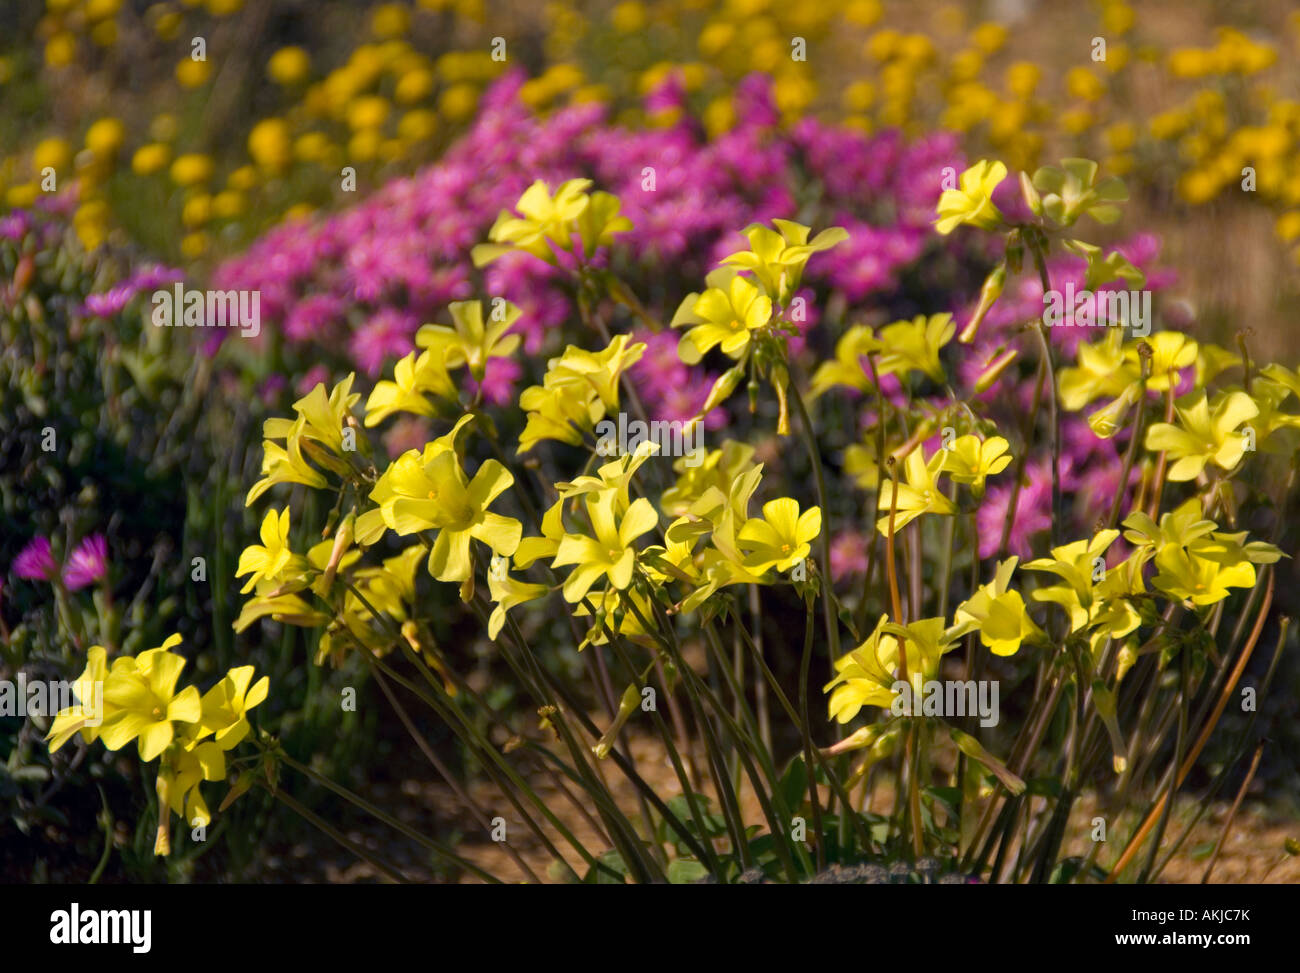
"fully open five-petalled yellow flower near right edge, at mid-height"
1144,389,1260,483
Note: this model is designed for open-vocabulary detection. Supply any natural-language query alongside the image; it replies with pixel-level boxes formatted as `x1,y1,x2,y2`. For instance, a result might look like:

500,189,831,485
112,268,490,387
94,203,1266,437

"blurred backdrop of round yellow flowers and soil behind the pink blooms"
0,0,1300,353
